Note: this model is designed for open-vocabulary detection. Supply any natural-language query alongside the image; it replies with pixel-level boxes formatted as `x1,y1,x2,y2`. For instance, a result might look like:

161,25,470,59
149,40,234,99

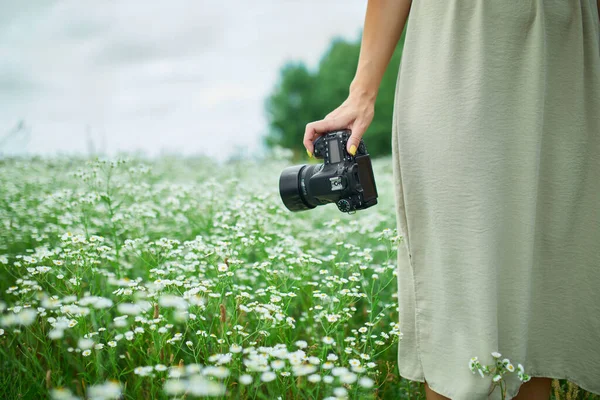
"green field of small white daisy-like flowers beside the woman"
0,156,428,399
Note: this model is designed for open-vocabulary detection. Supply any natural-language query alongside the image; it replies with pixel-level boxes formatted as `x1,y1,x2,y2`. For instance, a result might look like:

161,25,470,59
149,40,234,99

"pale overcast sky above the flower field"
0,0,367,161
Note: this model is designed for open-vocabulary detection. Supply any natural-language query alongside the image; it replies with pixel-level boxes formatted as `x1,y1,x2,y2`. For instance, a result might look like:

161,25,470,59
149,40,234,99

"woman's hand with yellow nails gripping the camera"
303,92,375,157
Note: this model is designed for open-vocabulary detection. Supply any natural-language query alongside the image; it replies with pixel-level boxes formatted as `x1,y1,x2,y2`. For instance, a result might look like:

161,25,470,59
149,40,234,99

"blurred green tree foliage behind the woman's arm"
264,29,404,158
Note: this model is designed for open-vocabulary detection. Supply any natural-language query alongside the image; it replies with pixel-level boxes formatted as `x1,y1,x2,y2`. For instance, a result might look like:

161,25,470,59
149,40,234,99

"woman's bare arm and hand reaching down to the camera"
303,0,412,156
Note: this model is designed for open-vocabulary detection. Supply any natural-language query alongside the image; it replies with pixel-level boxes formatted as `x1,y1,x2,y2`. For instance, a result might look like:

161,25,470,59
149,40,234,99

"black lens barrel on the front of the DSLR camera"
279,165,319,211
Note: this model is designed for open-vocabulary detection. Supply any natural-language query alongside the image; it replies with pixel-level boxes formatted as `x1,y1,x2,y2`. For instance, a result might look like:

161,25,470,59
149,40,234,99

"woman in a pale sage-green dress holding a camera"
304,0,600,400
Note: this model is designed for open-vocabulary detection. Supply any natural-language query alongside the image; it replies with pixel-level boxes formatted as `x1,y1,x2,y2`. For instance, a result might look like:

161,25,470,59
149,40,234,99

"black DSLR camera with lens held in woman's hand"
279,129,377,213
